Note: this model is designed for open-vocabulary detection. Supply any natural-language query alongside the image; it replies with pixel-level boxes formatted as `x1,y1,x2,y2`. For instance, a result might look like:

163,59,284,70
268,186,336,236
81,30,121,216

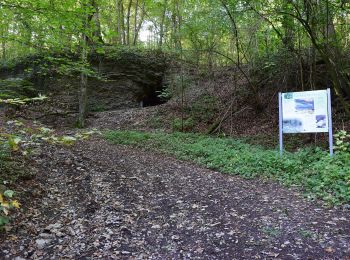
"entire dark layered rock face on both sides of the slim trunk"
0,47,167,112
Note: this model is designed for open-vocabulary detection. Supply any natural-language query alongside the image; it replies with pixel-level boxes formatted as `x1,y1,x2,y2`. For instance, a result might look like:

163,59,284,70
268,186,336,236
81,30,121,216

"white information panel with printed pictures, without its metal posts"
282,90,328,133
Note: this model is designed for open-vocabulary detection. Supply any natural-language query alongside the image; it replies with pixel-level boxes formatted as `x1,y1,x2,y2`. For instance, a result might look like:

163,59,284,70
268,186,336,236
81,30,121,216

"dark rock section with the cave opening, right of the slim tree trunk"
86,49,167,110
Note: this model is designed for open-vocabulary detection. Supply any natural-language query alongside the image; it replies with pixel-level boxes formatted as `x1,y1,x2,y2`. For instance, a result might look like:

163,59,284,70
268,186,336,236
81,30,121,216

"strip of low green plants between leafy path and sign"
104,131,350,204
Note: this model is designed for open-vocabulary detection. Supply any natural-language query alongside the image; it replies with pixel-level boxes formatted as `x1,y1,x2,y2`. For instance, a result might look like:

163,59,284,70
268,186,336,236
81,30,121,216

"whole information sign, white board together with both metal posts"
278,88,333,156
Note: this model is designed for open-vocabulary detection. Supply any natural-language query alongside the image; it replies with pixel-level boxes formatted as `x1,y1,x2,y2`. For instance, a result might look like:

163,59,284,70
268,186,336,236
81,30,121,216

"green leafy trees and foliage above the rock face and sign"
0,0,350,118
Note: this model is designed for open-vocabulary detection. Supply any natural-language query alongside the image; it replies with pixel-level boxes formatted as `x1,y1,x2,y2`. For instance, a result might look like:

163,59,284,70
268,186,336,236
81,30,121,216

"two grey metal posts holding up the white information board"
278,88,333,157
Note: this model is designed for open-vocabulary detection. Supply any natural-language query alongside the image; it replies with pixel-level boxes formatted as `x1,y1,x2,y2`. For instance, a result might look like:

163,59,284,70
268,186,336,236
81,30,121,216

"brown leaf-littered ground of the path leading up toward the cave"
0,108,350,259
